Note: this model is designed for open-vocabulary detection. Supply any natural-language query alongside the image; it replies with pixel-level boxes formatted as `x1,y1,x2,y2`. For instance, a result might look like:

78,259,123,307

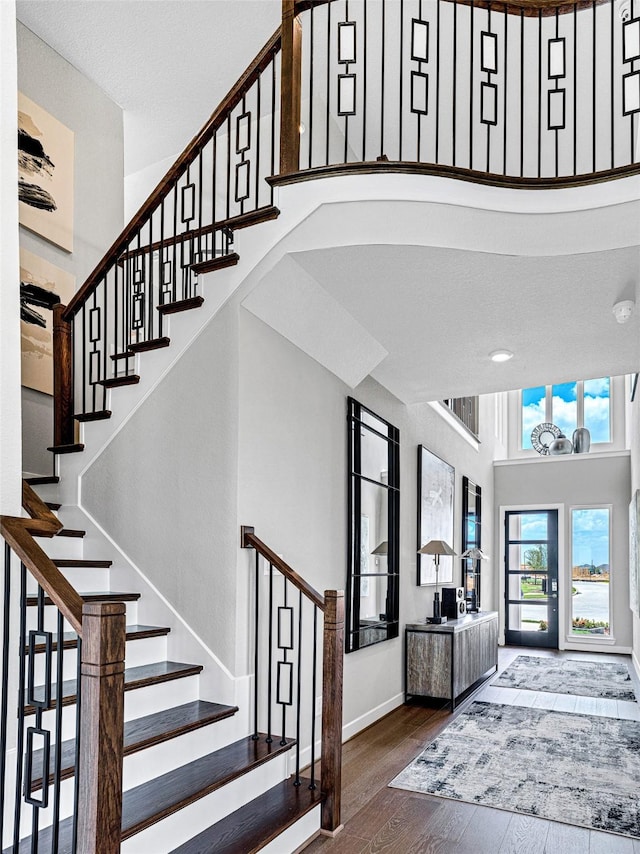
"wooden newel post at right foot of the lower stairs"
321,590,344,832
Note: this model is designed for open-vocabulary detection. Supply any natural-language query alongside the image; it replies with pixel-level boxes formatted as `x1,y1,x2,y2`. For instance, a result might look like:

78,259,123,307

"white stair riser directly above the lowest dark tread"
120,757,293,854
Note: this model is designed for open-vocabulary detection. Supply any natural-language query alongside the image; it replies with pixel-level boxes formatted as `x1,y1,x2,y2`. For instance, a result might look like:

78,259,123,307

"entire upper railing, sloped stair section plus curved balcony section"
54,0,640,438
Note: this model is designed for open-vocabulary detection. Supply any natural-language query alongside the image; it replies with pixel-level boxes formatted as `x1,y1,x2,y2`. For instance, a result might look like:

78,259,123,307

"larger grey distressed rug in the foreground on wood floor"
389,701,640,837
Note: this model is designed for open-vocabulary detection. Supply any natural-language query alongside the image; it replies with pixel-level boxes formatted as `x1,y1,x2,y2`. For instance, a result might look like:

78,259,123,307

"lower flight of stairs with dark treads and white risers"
4,477,332,854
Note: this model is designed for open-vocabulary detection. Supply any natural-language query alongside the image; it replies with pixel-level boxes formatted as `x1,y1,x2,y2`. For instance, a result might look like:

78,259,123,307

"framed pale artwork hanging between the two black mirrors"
417,445,456,586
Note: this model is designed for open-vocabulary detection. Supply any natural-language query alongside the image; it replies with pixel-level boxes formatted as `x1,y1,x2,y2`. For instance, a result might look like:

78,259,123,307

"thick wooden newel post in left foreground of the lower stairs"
78,602,126,854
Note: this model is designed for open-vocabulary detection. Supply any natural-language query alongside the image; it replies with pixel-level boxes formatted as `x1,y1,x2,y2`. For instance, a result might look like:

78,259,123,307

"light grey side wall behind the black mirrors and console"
237,312,502,735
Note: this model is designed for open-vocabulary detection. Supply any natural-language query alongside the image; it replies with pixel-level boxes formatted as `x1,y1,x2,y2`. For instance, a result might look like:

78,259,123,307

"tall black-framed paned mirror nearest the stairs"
345,397,400,652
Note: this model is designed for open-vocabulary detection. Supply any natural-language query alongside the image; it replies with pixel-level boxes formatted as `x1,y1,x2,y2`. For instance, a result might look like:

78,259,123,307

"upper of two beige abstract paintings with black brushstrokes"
18,92,74,252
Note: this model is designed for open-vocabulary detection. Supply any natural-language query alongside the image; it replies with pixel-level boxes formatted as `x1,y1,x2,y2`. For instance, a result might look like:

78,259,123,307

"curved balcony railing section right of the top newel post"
282,0,640,187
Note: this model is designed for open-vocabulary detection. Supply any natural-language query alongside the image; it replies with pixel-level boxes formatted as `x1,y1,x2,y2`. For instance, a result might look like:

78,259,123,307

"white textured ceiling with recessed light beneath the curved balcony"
282,245,640,403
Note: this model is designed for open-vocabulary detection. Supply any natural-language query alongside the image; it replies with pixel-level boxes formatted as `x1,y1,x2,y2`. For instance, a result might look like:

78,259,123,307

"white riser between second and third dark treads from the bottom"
124,718,237,789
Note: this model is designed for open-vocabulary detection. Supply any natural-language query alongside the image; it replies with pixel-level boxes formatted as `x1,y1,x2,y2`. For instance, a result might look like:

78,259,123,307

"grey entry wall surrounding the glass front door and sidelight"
493,452,632,652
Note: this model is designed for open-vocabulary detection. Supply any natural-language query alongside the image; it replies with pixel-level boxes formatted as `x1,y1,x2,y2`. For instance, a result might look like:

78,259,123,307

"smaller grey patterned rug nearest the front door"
491,655,636,701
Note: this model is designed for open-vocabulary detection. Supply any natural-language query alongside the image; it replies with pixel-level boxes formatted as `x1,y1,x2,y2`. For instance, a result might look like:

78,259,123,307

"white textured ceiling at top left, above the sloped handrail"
14,0,281,175
